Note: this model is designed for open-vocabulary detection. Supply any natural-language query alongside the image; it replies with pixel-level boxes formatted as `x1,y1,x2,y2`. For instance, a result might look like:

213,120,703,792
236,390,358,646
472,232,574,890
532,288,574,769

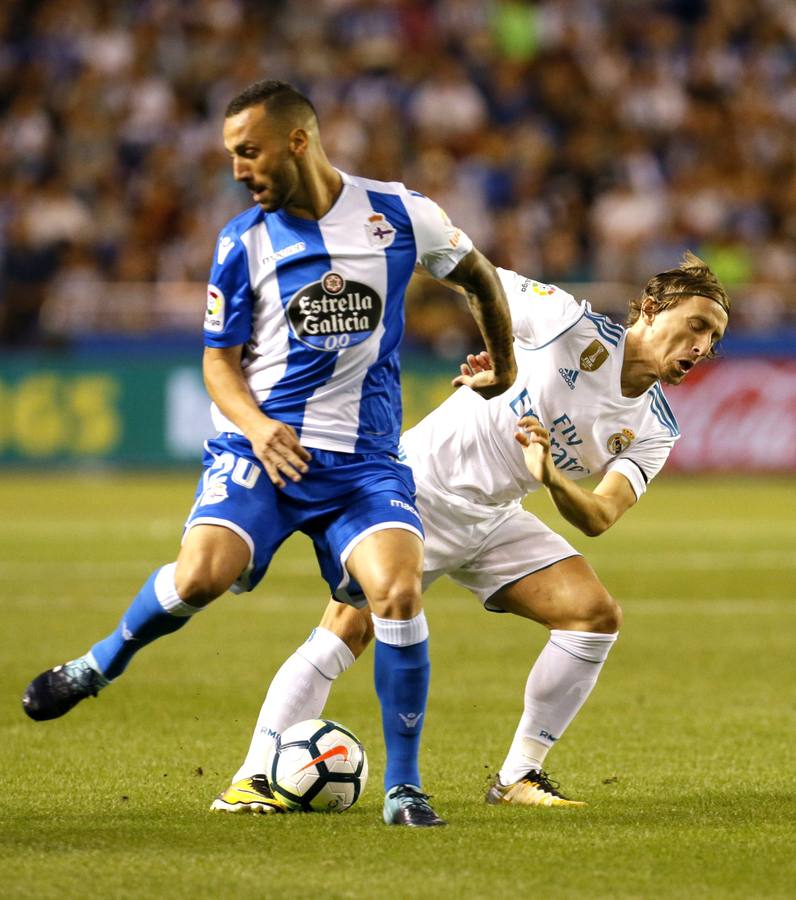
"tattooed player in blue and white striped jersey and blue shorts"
23,81,516,827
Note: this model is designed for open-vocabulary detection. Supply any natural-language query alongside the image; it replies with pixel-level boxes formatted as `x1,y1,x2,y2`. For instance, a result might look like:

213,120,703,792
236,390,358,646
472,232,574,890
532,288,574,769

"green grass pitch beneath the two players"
0,473,796,900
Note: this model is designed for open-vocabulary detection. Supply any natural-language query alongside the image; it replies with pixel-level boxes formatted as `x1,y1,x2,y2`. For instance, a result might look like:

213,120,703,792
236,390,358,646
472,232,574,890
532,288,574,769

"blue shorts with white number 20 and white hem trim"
185,433,424,606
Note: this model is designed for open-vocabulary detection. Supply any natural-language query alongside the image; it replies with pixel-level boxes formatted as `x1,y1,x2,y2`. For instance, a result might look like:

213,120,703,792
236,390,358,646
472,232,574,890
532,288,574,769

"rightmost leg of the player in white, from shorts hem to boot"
487,557,621,807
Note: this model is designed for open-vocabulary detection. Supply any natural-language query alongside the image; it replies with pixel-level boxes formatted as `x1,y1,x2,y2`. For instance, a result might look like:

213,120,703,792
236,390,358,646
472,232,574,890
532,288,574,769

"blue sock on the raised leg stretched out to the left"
91,567,195,679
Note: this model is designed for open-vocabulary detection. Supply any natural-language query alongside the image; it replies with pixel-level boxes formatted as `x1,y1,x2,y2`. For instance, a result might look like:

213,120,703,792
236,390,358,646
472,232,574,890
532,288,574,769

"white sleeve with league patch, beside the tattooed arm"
497,269,584,349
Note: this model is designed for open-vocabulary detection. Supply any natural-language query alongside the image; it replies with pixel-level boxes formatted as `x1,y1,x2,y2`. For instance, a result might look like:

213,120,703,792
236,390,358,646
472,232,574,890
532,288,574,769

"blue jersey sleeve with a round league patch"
204,230,254,347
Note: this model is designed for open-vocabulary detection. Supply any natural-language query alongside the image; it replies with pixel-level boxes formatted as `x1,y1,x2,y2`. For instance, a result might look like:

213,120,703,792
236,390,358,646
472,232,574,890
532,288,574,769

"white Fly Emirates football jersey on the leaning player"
401,269,679,506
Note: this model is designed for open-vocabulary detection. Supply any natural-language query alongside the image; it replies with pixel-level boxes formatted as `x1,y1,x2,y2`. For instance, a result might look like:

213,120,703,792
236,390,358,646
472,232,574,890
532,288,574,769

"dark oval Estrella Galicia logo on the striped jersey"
286,272,384,352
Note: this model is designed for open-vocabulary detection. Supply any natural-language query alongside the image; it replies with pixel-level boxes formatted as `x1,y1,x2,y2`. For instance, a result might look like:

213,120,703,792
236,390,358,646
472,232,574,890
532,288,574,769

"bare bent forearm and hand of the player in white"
514,416,636,537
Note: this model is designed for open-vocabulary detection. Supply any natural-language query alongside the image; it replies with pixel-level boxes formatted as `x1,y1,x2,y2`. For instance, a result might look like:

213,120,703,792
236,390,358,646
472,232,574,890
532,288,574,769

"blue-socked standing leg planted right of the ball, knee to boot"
346,528,445,828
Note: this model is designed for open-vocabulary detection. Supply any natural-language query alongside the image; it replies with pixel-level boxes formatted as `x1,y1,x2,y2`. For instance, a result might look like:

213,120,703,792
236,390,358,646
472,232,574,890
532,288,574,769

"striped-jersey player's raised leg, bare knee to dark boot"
22,526,249,721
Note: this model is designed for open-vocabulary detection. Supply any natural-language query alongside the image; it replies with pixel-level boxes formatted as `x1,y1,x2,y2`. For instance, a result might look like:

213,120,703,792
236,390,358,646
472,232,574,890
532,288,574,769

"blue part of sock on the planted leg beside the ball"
374,639,431,791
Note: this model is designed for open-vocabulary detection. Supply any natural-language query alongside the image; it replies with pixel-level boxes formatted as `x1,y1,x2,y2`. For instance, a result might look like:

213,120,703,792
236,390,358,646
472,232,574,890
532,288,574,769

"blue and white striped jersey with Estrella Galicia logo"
204,172,472,453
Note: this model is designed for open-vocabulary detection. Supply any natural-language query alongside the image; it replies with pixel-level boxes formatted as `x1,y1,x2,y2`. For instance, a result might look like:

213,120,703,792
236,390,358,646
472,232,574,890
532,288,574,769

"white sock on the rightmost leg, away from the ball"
500,629,619,784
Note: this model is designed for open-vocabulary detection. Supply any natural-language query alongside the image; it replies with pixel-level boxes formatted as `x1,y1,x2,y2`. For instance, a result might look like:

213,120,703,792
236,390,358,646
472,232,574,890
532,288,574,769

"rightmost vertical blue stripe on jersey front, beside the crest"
355,191,417,453
